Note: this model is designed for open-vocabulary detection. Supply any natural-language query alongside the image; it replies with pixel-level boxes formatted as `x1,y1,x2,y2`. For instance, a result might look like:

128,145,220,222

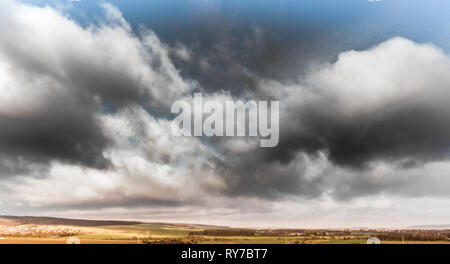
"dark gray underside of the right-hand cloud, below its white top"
265,102,450,168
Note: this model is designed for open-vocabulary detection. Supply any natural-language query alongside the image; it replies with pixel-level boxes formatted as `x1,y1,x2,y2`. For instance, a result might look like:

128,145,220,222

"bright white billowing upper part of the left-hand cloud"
0,1,190,114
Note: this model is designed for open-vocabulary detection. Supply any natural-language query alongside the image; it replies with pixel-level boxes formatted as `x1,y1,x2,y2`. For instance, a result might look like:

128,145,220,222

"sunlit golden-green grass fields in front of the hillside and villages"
0,223,450,244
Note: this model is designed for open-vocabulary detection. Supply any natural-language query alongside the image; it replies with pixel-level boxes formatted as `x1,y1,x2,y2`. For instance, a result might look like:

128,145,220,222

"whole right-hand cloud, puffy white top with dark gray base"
272,38,450,167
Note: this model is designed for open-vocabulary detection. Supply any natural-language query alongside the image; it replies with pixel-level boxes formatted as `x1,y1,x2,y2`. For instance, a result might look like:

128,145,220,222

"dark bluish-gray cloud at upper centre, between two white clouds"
171,18,342,98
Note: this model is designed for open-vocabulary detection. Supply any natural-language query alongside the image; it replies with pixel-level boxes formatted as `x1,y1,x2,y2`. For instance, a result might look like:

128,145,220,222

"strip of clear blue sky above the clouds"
24,0,450,50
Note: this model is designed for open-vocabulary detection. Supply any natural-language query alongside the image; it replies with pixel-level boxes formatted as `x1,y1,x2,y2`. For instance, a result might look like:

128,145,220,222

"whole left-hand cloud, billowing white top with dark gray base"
0,1,189,169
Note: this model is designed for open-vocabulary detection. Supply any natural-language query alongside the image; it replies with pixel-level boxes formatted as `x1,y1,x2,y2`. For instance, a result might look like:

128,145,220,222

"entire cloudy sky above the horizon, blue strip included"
0,0,450,228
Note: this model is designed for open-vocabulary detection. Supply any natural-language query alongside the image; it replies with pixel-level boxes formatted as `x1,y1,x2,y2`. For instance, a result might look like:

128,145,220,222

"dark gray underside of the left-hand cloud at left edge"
0,103,108,168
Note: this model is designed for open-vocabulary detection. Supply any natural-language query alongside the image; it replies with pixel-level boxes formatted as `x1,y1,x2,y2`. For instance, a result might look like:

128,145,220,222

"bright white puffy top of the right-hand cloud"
308,38,450,114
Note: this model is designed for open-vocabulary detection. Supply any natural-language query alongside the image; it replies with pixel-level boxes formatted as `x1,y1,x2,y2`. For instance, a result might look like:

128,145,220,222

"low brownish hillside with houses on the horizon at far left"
0,215,142,226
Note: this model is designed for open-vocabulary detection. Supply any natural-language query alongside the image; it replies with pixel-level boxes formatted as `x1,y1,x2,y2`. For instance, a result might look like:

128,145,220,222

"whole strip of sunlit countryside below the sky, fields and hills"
0,216,450,244
